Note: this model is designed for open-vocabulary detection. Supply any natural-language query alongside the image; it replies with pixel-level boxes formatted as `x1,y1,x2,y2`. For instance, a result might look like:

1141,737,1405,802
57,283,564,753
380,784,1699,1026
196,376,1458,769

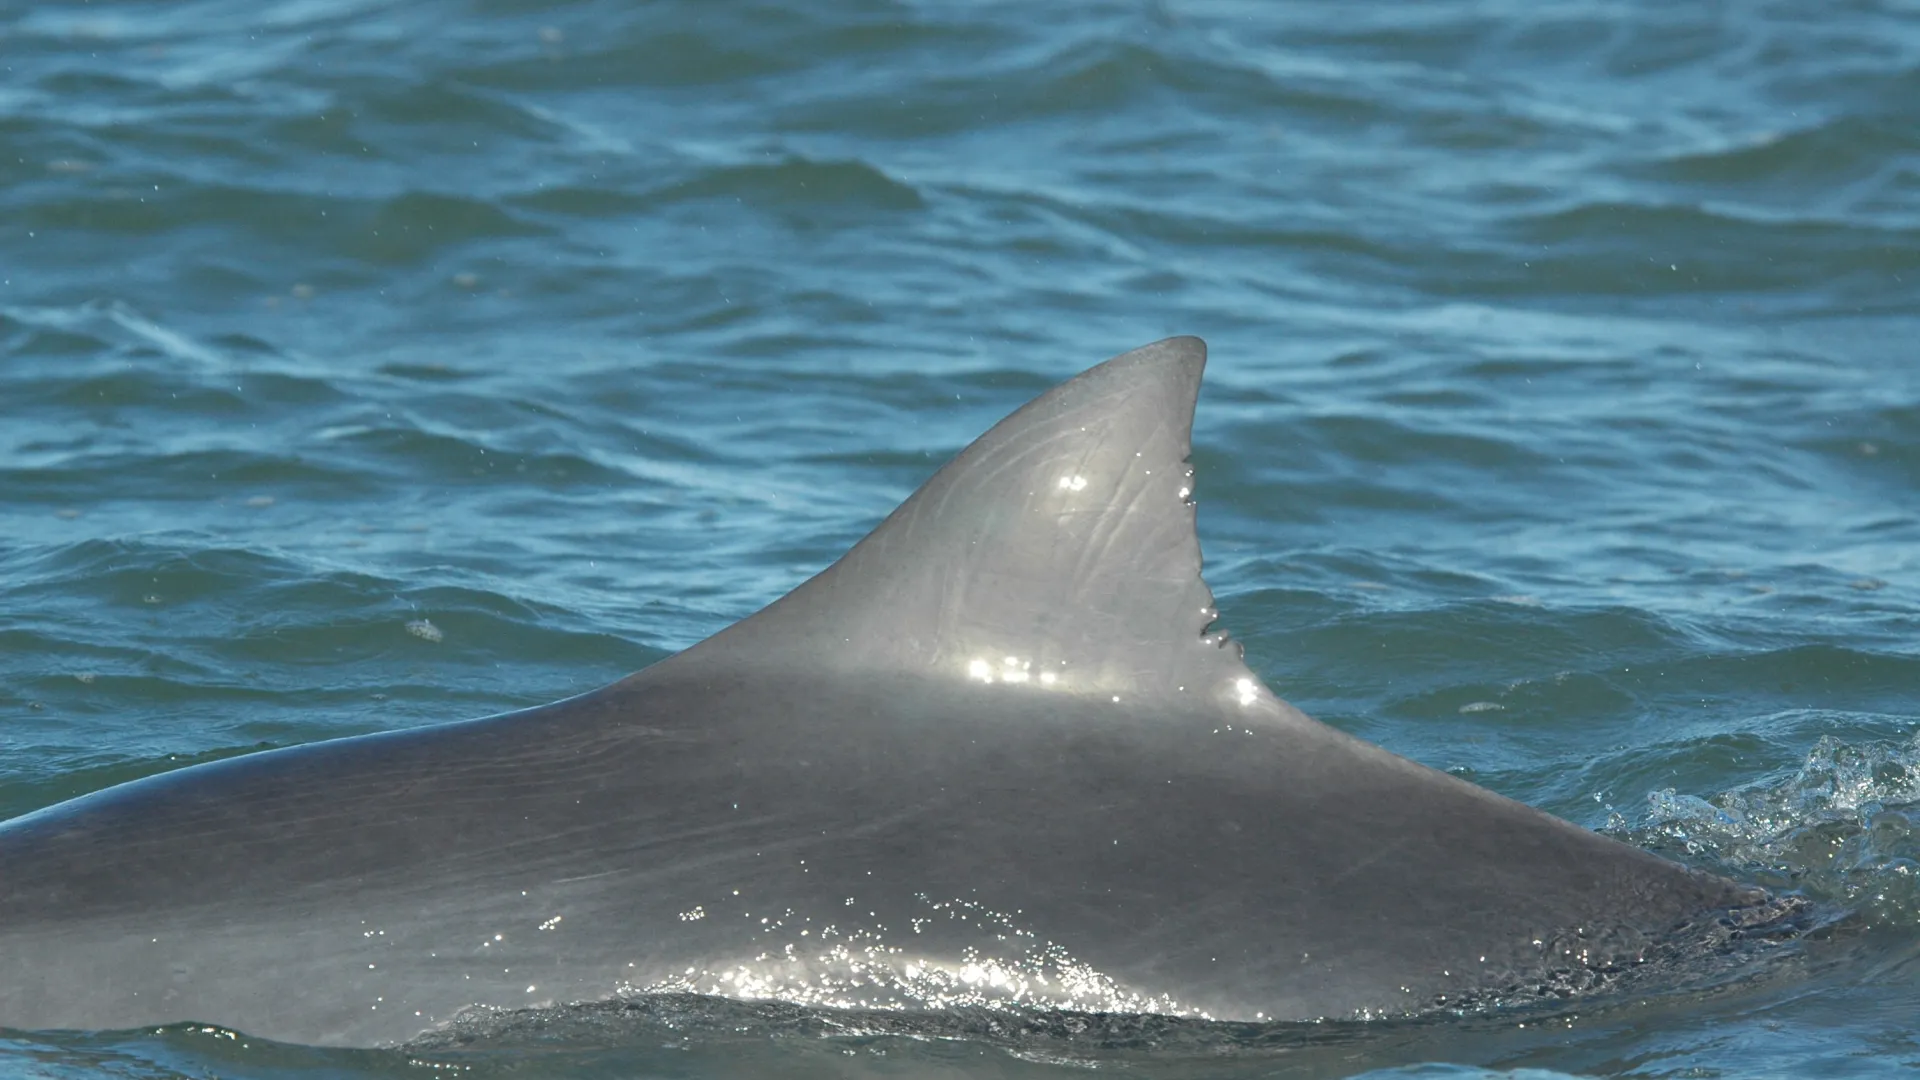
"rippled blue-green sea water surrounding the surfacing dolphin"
0,0,1920,1078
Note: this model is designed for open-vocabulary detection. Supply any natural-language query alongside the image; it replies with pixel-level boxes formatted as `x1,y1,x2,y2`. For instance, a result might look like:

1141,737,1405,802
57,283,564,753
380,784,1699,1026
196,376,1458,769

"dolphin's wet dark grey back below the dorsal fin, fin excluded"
0,664,1755,1045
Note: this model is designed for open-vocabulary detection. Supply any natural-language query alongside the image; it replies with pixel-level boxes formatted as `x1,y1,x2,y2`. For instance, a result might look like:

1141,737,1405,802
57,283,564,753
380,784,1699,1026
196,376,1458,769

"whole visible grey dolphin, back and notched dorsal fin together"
0,338,1770,1045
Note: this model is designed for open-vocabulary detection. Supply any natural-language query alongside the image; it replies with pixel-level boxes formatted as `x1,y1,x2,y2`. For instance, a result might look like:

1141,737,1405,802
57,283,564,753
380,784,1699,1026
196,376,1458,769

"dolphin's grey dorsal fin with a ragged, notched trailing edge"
682,338,1263,703
